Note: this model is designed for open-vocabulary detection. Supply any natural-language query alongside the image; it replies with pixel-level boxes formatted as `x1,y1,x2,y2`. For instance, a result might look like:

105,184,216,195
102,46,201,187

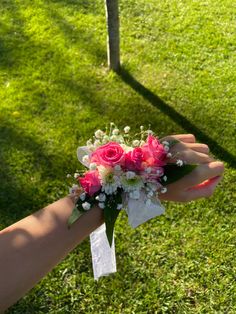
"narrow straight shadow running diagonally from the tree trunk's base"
117,67,236,169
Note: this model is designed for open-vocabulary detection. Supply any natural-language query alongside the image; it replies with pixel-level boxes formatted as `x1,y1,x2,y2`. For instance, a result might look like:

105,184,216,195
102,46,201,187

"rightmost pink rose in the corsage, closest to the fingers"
142,135,166,167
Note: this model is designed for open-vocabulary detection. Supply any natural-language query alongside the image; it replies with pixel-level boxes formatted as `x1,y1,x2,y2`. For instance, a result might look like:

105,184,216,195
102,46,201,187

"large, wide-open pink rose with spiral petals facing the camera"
90,142,124,167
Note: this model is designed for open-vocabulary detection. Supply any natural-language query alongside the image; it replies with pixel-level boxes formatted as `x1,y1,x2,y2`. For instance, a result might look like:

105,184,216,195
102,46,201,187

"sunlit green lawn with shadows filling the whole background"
0,0,236,314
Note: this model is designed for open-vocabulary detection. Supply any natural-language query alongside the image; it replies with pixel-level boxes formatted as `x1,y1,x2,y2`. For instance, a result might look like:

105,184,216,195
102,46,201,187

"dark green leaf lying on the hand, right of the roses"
161,164,197,186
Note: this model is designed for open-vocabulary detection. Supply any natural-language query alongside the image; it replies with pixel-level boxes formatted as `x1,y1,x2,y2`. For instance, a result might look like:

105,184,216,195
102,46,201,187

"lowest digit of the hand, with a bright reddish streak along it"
184,176,222,201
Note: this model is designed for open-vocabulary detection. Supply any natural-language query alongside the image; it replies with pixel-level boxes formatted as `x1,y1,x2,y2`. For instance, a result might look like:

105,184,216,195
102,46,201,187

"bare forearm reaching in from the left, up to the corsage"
0,197,103,312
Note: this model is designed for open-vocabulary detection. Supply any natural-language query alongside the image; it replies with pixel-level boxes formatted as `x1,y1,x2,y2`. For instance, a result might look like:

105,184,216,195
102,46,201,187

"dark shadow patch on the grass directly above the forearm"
0,121,71,225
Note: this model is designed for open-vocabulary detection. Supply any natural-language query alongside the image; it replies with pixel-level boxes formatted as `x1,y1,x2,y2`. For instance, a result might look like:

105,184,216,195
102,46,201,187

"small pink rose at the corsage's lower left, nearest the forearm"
78,170,101,196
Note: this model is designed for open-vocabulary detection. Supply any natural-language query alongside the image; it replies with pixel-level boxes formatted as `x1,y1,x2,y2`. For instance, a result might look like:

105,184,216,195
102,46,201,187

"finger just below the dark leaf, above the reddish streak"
169,161,224,190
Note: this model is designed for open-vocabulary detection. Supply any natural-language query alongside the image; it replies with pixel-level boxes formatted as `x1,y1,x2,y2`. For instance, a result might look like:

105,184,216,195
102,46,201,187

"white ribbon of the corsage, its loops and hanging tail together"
77,146,165,280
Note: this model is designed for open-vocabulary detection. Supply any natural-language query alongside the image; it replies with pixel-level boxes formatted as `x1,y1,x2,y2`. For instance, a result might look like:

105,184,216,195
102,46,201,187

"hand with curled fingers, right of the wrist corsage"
159,134,224,202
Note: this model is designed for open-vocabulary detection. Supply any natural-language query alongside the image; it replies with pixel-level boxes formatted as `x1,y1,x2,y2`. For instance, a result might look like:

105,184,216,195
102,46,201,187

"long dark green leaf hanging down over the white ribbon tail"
104,191,122,246
